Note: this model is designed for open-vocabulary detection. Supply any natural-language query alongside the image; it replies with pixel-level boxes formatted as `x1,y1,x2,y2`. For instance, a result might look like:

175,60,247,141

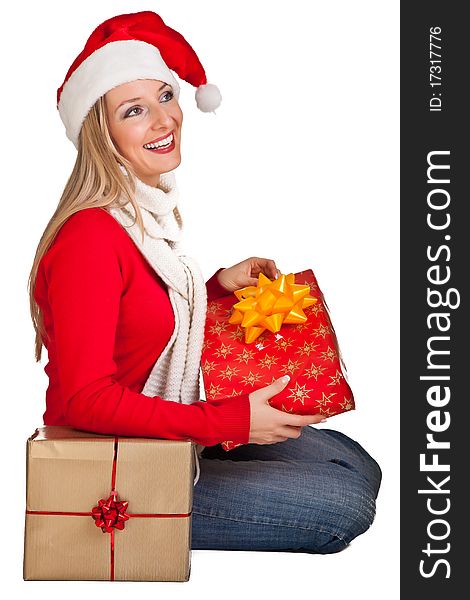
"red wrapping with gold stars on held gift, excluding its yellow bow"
201,269,355,450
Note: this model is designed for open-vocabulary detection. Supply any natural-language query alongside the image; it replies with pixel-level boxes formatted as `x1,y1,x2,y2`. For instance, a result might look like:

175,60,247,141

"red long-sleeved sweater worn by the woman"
34,208,250,446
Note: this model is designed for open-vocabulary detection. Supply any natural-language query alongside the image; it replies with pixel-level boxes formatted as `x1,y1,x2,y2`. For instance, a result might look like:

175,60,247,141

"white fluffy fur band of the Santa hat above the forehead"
58,40,180,148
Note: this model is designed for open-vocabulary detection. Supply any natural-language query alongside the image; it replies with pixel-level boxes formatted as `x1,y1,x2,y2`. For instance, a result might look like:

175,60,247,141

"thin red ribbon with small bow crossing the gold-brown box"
26,437,191,581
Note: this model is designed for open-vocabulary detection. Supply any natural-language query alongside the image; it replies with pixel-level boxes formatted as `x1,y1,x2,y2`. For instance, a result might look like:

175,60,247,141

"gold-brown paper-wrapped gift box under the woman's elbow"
23,426,196,581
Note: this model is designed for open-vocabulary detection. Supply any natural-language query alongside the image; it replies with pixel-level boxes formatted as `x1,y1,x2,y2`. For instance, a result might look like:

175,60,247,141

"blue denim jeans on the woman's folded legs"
191,426,382,554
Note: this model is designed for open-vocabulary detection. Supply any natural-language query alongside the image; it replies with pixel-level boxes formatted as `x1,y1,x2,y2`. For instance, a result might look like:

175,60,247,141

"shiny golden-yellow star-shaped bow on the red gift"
229,273,317,344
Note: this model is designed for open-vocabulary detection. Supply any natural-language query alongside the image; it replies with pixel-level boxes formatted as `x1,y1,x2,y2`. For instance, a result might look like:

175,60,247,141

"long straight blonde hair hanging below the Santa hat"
28,96,144,362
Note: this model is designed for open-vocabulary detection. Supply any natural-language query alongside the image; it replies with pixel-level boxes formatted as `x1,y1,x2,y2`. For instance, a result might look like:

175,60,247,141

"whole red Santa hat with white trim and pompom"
57,11,222,147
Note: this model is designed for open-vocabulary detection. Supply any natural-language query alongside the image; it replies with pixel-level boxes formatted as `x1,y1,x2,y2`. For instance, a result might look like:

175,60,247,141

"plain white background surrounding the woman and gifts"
0,0,399,600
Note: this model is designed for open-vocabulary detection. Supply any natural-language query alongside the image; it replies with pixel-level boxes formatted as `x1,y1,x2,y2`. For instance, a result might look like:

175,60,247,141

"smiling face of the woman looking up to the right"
105,79,183,187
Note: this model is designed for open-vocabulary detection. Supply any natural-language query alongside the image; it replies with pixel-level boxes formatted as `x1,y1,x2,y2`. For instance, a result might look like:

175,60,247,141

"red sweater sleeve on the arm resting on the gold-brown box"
45,215,250,446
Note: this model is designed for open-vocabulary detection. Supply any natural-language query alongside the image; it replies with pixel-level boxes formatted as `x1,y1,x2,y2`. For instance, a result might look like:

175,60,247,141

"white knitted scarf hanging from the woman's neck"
109,169,207,484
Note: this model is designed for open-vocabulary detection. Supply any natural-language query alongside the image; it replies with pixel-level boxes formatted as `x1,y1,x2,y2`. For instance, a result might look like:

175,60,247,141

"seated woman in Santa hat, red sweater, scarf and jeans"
30,11,381,553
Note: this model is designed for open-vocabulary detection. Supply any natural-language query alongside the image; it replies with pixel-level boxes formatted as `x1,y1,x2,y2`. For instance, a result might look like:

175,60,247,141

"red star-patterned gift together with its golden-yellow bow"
201,269,355,450
